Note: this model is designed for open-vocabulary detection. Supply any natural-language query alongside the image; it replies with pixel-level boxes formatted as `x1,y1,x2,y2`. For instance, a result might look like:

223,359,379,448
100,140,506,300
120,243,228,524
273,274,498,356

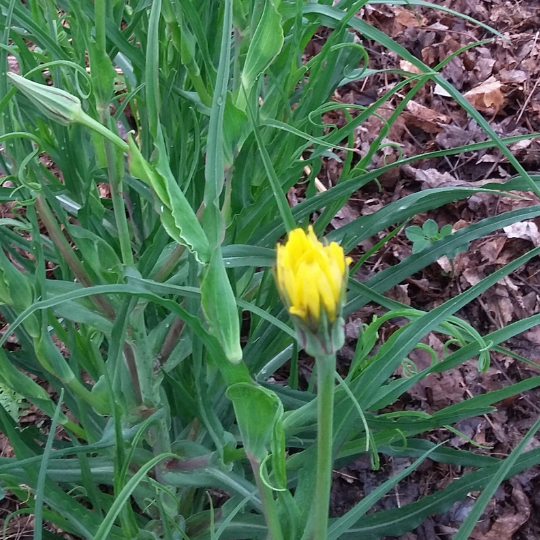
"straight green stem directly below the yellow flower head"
313,354,336,540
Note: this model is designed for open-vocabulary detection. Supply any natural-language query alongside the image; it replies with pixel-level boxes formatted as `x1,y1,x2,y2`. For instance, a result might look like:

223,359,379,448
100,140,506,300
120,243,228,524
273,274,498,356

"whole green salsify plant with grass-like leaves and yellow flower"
0,0,540,540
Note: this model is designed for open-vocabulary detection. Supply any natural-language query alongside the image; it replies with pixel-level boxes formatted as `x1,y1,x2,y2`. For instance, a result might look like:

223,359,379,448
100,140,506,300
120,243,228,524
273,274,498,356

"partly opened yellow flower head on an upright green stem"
276,226,352,330
